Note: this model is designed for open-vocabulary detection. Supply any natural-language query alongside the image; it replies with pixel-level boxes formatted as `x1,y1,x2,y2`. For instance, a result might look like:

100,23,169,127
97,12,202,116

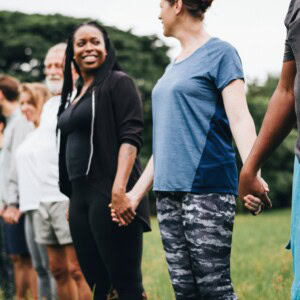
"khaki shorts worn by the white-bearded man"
34,201,72,245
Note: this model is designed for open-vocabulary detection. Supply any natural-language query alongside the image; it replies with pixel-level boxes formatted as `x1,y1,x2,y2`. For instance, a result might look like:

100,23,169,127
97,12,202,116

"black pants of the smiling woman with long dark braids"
69,179,144,300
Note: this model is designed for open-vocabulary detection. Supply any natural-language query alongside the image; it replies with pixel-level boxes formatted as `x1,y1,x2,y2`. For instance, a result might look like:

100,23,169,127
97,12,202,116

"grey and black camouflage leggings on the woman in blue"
156,192,237,300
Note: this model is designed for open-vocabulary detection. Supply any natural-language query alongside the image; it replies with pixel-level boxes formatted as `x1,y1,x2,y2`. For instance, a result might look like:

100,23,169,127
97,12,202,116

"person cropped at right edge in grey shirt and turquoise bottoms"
239,0,300,300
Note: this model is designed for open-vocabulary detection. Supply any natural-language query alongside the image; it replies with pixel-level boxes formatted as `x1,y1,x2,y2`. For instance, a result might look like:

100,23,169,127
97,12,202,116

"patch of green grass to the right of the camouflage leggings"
231,210,293,300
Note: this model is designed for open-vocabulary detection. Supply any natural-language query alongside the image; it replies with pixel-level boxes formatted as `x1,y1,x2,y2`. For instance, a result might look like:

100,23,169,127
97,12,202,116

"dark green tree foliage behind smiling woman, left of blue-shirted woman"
0,11,169,162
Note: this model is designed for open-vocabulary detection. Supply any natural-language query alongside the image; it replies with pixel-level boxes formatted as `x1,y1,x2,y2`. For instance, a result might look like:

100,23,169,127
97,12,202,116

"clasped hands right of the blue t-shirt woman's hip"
239,170,272,215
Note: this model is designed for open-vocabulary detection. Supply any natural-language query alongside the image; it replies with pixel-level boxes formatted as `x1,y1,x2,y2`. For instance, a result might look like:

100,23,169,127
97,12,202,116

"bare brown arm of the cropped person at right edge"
239,61,296,203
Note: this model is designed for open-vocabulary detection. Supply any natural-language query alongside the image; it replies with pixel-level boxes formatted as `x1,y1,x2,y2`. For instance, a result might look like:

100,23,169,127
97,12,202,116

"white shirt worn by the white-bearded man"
36,96,68,202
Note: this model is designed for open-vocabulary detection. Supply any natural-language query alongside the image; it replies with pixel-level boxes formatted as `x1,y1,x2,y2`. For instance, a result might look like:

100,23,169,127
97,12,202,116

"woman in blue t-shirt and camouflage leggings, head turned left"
112,0,267,300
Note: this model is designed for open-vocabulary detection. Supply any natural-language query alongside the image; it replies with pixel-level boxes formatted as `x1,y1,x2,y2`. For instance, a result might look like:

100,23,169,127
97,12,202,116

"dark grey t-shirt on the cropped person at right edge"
283,0,300,160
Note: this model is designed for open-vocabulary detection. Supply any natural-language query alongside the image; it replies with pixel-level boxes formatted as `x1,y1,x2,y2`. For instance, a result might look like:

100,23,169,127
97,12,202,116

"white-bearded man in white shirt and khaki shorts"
34,43,92,300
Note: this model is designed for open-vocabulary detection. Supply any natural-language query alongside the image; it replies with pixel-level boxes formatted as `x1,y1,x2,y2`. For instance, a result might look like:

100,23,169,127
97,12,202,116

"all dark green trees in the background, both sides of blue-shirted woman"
0,11,297,210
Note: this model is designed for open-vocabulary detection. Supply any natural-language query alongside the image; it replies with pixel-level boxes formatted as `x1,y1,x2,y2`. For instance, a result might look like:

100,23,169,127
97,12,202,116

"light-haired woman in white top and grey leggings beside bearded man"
9,83,56,300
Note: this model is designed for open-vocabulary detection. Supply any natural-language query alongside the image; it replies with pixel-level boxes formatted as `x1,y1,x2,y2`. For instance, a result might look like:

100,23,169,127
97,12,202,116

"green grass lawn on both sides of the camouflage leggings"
143,210,292,300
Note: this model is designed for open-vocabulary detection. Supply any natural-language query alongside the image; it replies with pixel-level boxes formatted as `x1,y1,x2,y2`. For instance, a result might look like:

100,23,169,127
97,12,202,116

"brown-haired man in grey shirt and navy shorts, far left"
0,76,37,299
